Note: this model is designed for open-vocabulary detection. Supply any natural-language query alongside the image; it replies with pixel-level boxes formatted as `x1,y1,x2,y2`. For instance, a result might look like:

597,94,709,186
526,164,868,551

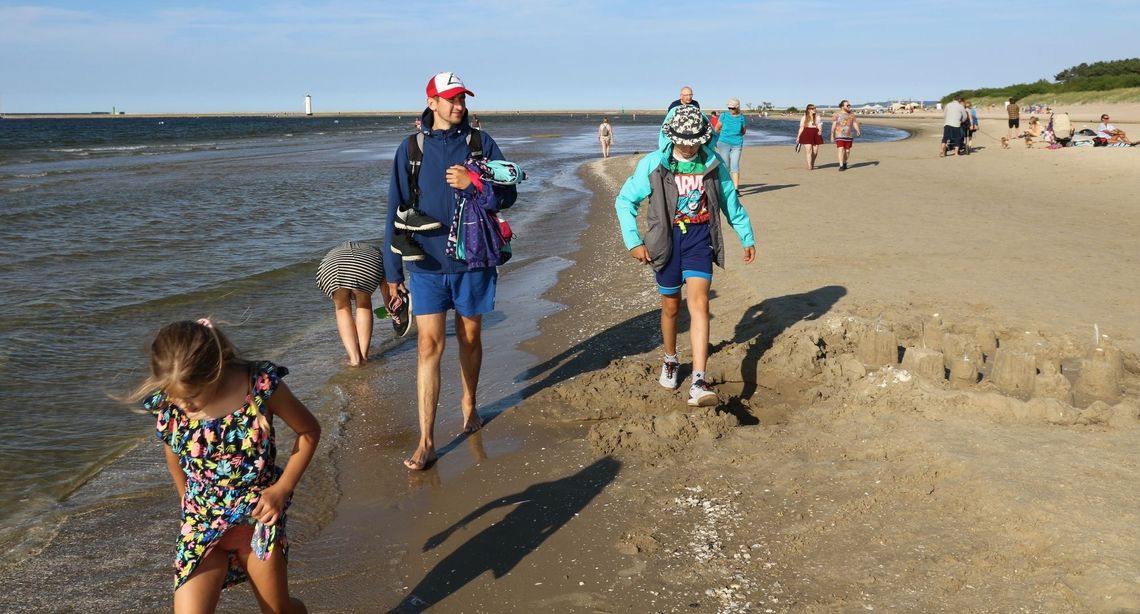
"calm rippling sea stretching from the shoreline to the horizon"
0,109,905,580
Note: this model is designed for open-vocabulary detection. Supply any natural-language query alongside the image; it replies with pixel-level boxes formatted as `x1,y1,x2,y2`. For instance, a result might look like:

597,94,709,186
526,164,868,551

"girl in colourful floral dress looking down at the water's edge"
135,320,320,613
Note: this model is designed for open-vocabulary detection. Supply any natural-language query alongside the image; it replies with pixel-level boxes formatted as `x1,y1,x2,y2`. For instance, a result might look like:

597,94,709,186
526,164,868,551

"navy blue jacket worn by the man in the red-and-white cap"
384,109,519,284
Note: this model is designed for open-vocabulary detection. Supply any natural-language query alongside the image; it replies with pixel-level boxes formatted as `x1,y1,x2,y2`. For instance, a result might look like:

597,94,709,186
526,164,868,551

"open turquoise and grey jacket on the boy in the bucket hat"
613,112,756,271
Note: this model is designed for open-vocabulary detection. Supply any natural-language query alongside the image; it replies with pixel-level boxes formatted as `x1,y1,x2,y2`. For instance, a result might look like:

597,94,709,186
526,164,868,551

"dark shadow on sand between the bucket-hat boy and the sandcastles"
710,286,847,399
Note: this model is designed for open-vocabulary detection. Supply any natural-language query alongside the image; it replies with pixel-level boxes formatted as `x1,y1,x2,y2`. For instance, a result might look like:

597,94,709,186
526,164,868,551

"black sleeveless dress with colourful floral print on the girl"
143,362,288,590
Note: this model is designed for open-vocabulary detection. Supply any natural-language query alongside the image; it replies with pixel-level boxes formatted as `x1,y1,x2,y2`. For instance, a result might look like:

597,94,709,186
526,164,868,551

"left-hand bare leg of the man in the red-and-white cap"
404,313,447,470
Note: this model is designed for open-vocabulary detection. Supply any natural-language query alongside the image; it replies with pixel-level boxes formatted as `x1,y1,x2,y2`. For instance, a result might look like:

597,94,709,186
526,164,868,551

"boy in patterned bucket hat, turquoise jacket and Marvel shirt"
613,105,756,407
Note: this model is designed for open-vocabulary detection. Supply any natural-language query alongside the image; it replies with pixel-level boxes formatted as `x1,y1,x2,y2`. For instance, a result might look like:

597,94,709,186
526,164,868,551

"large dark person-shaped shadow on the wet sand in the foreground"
390,457,621,614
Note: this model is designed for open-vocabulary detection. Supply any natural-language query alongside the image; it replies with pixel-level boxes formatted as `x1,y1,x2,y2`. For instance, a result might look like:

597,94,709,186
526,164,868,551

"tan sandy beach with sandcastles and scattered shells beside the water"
275,120,1140,612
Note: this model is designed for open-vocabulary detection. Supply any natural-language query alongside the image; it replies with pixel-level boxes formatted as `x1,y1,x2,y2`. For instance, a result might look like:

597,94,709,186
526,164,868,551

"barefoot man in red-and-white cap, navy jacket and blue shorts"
384,73,518,470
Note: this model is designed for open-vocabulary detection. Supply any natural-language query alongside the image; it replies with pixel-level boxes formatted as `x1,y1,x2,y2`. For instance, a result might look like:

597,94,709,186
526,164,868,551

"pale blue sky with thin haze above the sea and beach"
0,0,1140,113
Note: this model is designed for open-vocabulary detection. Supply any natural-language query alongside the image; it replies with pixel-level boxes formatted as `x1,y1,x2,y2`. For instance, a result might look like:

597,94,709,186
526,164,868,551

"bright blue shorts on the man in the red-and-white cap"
408,269,498,318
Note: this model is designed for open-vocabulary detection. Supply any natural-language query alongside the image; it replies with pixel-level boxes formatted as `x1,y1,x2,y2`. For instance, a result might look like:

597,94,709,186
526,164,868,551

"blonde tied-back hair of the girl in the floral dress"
128,320,245,401
